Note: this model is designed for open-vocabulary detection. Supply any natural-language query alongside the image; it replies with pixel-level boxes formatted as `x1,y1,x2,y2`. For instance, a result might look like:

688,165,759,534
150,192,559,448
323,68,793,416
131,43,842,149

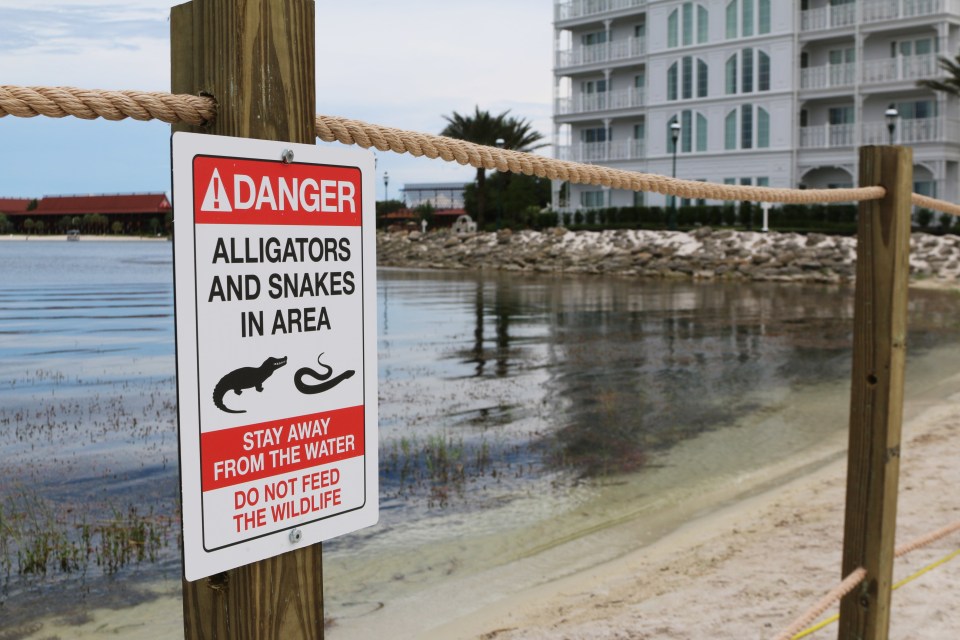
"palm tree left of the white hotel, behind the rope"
440,106,546,229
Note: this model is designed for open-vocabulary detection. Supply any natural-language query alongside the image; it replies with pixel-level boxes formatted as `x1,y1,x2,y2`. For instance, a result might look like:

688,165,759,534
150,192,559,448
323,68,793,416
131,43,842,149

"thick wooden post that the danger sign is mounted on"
170,0,323,640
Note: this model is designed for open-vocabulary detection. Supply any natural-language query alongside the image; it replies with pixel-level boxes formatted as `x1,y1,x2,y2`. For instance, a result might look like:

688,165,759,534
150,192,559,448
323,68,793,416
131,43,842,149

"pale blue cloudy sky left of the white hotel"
0,0,553,199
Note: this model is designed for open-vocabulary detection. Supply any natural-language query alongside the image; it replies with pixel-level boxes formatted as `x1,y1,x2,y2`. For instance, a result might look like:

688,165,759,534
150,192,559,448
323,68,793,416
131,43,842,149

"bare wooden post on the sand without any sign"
838,147,913,640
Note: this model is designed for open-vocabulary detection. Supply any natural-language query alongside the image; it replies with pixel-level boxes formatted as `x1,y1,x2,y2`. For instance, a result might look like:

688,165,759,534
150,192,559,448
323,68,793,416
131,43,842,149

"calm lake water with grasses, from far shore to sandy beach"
0,241,960,638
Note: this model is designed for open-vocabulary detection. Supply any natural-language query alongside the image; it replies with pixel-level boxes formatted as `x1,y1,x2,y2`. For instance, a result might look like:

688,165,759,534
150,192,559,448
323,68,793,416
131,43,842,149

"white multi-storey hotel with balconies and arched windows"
553,0,960,211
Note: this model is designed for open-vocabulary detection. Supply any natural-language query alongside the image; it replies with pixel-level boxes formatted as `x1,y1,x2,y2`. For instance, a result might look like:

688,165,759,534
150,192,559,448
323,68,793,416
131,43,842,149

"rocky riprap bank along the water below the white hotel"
377,227,960,283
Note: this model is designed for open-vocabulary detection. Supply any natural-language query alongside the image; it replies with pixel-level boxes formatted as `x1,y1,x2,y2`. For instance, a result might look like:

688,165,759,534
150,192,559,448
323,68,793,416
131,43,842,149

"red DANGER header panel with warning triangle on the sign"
193,156,363,227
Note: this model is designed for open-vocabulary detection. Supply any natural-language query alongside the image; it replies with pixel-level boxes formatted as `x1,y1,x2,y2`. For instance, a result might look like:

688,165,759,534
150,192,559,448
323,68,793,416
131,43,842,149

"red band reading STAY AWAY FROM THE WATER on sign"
200,405,364,491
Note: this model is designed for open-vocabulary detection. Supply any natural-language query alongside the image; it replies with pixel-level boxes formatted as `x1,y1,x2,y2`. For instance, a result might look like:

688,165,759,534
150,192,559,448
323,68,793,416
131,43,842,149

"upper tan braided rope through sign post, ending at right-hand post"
0,86,886,204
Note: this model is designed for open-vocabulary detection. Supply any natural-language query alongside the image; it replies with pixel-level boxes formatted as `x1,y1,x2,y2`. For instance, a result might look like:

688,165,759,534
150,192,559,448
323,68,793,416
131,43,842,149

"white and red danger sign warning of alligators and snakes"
173,132,378,580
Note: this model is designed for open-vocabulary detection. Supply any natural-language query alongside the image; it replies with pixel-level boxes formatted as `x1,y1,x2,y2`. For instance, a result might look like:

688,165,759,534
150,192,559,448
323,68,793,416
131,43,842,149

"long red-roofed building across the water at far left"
0,193,173,235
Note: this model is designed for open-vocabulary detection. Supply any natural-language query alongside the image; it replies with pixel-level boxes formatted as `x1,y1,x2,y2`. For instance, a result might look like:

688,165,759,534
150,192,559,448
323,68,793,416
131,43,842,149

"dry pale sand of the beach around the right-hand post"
431,374,960,640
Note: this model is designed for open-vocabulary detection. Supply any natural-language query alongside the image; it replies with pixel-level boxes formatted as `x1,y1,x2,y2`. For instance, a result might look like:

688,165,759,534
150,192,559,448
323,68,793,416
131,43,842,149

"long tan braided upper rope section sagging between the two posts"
317,115,886,204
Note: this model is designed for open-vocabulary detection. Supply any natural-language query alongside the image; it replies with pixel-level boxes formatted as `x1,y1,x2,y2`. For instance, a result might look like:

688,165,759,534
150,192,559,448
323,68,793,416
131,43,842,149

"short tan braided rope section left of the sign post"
0,86,216,125
